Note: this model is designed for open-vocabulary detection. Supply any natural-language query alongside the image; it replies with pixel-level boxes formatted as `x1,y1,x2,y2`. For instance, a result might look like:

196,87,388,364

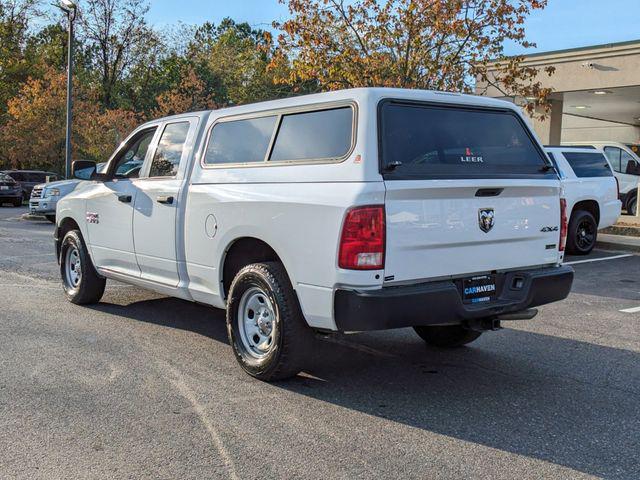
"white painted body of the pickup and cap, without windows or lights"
57,89,562,330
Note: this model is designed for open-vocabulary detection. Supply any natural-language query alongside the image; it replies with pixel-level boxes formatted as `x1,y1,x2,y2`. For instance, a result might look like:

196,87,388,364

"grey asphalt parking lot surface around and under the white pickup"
0,207,640,479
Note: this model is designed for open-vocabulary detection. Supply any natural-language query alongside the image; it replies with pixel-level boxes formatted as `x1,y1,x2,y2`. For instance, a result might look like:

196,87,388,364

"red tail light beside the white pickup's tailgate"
338,205,385,270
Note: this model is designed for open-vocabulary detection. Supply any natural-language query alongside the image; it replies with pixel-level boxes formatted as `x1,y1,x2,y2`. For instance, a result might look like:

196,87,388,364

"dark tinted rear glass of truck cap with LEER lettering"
379,100,557,179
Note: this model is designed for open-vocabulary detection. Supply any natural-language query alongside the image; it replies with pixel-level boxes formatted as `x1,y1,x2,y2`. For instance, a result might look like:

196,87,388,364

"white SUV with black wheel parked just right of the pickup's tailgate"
546,147,622,255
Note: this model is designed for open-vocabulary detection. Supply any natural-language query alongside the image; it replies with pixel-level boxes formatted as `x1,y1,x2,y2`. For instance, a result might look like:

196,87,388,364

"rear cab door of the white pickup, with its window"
133,118,198,287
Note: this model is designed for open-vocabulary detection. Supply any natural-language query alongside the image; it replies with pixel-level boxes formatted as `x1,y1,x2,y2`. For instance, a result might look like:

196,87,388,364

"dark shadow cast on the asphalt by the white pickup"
94,298,640,479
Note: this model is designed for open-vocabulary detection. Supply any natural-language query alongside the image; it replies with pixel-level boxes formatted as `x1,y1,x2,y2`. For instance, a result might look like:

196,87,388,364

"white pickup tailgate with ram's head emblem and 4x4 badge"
385,180,560,281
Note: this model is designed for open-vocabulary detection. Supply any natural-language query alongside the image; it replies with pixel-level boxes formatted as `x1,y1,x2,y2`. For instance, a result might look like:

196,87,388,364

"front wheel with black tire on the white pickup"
60,230,107,305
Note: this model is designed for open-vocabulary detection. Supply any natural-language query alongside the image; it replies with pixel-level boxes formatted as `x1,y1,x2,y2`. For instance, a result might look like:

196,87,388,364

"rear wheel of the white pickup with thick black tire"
227,262,313,382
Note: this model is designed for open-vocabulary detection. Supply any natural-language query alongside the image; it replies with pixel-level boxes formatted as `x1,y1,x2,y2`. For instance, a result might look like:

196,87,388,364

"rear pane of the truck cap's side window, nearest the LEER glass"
270,107,353,162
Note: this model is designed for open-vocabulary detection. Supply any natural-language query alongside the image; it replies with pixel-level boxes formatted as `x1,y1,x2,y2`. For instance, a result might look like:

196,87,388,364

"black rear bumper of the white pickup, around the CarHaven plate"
334,266,573,332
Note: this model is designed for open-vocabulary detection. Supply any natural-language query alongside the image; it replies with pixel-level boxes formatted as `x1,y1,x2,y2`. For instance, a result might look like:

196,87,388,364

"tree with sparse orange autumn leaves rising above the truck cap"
273,0,553,111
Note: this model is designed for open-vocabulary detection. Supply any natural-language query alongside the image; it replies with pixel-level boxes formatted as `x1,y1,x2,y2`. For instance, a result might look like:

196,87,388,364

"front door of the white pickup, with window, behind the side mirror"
86,126,157,276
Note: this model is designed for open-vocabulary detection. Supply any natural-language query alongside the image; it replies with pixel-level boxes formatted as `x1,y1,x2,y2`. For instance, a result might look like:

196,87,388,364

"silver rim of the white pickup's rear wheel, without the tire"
238,287,277,359
